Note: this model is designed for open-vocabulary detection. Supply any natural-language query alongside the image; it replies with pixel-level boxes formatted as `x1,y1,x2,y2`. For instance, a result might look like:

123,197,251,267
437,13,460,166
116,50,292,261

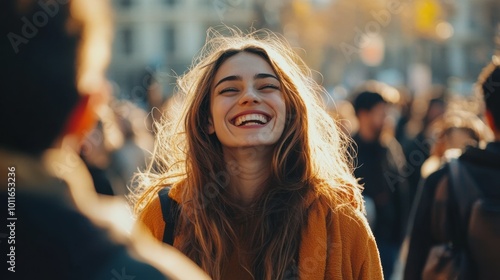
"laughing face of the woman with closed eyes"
209,52,286,148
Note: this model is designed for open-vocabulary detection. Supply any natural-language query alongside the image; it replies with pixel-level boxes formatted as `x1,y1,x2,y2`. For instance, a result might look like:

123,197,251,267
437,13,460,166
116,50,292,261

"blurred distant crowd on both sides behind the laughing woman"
4,0,495,279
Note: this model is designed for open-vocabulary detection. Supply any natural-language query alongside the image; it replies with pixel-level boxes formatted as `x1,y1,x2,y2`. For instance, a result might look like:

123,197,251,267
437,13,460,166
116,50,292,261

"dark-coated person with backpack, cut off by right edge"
404,59,500,279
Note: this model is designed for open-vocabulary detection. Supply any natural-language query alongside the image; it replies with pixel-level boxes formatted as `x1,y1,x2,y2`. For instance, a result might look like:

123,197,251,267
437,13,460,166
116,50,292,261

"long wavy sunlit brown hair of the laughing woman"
133,27,364,279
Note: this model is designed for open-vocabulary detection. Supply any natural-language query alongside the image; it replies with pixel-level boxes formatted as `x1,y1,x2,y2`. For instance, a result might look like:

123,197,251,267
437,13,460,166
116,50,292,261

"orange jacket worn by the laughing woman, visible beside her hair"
139,187,383,280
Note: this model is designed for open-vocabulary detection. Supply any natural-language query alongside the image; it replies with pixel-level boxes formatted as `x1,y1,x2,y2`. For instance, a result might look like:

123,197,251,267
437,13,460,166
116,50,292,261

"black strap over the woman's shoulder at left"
158,187,179,245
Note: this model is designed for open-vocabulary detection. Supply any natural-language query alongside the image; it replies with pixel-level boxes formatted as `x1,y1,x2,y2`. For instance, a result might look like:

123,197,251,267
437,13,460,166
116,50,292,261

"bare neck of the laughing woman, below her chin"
224,147,272,206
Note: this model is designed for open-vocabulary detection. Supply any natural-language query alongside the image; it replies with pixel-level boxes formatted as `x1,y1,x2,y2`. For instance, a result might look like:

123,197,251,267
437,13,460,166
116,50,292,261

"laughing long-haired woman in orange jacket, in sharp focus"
134,27,382,279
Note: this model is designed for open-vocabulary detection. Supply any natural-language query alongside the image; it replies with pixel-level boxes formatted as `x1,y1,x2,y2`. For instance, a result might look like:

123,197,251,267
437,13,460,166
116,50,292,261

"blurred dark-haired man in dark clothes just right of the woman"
351,87,409,279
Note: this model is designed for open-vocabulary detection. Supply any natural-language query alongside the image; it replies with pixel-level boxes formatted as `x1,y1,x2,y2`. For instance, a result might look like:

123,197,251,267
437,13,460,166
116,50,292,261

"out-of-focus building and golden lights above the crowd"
109,0,500,104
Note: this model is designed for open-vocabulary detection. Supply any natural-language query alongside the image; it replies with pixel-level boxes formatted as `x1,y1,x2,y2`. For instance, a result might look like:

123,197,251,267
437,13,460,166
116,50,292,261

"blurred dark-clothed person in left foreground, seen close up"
0,0,207,280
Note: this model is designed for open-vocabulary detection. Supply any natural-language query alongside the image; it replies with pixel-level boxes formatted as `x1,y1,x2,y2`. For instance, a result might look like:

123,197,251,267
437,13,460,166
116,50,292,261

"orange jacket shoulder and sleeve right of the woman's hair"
302,185,380,274
